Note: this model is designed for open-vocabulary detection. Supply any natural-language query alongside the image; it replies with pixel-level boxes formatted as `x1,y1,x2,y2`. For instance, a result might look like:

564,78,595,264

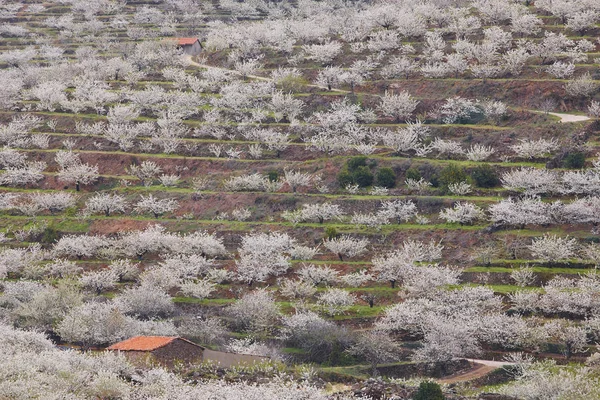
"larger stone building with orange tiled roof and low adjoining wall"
107,336,268,368
